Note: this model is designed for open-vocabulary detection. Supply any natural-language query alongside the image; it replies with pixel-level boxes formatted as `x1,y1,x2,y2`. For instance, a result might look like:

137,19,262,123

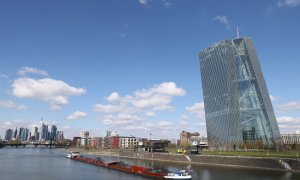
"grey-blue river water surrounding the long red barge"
0,147,300,180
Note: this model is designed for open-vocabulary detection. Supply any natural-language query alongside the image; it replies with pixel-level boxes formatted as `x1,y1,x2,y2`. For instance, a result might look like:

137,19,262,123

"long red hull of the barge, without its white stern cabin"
70,157,166,179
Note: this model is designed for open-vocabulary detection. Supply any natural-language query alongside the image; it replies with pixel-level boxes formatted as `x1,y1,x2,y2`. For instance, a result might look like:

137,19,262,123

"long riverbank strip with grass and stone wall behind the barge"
68,150,300,172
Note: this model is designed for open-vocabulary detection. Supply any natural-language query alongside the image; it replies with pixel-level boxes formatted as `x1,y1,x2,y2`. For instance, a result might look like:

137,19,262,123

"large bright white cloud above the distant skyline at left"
12,77,86,109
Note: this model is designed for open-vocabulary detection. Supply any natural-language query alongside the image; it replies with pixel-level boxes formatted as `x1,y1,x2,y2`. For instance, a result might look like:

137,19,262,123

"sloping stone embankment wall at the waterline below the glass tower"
120,152,300,171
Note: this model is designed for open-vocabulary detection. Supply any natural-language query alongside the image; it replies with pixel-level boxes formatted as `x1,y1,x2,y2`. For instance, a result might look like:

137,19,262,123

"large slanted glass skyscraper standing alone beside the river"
200,38,281,147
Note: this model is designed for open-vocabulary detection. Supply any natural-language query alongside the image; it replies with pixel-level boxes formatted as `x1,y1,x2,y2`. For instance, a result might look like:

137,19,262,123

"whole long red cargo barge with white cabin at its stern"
67,152,191,179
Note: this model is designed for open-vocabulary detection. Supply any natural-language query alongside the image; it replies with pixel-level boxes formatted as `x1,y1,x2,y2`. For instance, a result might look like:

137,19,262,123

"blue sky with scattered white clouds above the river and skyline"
0,0,300,139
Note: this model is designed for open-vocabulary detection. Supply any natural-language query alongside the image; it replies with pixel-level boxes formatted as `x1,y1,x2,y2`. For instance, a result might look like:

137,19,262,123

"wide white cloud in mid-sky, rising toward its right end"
94,82,186,113
